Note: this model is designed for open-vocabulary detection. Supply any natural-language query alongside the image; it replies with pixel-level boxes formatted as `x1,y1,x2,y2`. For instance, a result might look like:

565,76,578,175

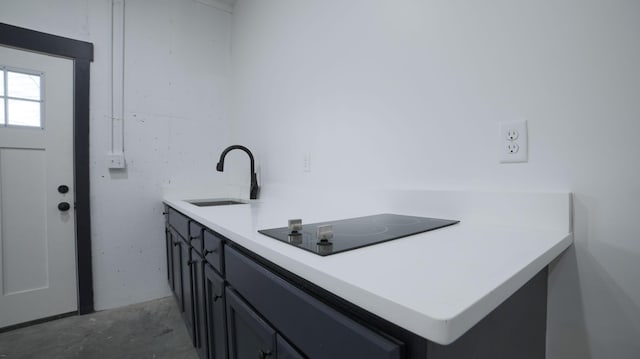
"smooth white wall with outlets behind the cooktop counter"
232,0,640,359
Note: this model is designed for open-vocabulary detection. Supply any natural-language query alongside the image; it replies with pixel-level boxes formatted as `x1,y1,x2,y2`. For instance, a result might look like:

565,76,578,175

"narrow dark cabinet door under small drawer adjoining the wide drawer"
204,263,227,359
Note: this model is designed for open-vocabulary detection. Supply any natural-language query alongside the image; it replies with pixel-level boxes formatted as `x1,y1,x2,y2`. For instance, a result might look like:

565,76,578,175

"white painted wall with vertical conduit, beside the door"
0,0,231,309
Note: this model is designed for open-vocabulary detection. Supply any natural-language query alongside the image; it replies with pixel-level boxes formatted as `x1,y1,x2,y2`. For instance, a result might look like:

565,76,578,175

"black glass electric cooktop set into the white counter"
258,214,460,256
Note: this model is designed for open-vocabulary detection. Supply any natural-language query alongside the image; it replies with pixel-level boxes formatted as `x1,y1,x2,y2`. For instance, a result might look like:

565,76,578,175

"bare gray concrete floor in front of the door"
0,297,198,359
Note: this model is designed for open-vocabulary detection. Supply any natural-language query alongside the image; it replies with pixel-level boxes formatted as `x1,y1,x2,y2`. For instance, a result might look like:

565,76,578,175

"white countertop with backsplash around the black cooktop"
164,187,572,345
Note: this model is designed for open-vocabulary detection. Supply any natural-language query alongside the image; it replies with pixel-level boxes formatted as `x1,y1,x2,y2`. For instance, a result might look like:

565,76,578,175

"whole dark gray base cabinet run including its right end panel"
165,208,547,359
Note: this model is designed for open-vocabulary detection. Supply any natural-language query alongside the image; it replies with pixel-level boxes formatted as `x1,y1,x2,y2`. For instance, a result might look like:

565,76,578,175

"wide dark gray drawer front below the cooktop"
225,246,403,359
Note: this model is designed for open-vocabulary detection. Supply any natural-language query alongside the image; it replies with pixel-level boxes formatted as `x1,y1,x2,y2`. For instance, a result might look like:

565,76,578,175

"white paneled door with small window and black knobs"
0,46,78,328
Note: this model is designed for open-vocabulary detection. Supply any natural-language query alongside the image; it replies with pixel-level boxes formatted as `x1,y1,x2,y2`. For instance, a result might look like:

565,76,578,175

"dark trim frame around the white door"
0,23,94,314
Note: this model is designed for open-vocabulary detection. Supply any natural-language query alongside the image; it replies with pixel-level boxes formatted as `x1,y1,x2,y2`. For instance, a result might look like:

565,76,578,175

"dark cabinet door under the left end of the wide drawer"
226,290,276,359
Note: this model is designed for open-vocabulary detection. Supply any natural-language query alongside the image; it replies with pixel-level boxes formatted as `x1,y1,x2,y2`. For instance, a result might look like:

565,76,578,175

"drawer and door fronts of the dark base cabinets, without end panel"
165,208,402,359
